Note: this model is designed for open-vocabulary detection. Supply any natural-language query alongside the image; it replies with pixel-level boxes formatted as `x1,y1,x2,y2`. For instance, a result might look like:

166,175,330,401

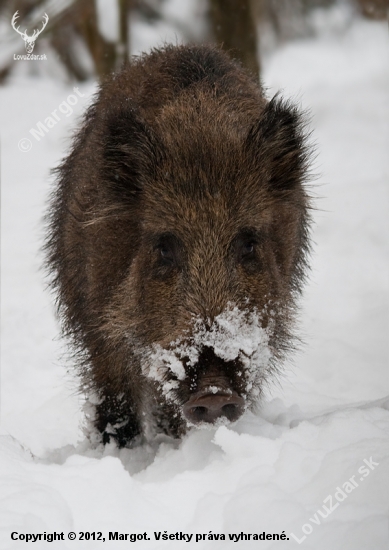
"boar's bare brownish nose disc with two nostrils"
183,391,244,424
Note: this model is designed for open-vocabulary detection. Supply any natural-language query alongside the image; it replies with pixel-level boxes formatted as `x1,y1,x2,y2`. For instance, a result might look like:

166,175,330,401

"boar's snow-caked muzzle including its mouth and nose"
142,307,272,427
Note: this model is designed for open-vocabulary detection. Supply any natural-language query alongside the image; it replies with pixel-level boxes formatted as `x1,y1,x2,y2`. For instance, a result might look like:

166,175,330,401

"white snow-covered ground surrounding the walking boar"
0,9,389,550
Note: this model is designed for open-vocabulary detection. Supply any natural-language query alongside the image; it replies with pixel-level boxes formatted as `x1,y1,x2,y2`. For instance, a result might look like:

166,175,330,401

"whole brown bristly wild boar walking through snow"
46,46,309,446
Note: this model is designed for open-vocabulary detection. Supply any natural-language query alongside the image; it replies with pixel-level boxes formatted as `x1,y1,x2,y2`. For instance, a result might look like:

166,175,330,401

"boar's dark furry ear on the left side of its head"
103,107,162,200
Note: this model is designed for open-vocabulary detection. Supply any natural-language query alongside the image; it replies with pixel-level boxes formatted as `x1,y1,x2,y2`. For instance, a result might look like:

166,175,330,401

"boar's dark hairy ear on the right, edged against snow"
246,96,309,191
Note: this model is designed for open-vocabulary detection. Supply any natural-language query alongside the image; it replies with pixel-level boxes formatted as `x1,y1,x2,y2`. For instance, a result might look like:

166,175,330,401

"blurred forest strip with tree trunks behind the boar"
0,0,388,83
